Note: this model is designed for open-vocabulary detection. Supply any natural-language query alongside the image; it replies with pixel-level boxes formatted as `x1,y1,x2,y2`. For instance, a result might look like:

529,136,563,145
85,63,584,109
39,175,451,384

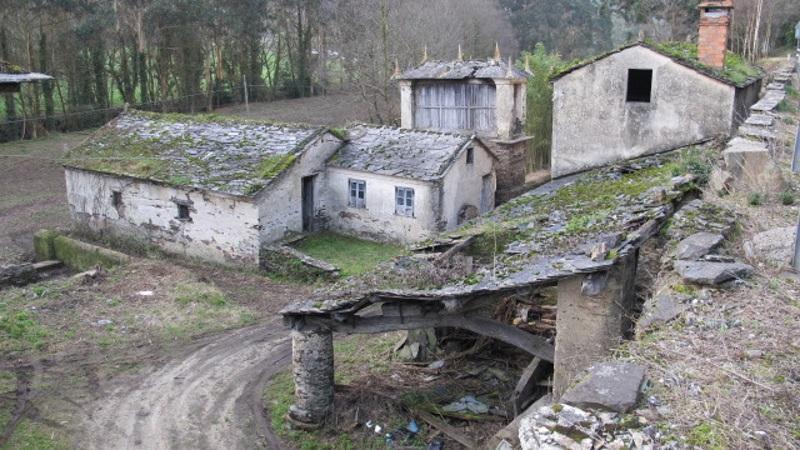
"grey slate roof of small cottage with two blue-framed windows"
328,124,475,181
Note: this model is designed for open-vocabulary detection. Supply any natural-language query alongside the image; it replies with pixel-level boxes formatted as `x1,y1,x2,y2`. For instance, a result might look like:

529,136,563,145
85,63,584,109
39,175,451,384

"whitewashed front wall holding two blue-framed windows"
325,167,441,244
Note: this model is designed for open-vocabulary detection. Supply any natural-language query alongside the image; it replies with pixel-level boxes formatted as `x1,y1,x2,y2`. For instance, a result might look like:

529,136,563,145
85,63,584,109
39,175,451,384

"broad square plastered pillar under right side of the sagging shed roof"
553,254,637,399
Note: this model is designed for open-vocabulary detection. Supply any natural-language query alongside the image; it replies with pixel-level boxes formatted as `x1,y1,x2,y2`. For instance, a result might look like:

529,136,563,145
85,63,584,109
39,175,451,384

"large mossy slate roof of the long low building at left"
65,111,327,196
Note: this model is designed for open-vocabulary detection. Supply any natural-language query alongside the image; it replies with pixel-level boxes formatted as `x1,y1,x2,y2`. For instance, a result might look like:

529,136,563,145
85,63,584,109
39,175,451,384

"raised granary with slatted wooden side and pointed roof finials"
395,50,531,203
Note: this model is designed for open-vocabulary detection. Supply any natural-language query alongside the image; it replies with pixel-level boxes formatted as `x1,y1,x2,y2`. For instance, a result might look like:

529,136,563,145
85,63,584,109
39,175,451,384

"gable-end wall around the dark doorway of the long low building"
256,133,342,244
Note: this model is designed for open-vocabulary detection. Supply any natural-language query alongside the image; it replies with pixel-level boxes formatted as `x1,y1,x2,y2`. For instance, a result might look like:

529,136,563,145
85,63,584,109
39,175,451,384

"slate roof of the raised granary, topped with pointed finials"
397,59,530,80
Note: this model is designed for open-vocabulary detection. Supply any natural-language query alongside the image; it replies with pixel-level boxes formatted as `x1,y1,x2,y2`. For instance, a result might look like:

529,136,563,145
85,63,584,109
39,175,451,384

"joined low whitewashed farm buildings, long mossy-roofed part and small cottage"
65,111,495,265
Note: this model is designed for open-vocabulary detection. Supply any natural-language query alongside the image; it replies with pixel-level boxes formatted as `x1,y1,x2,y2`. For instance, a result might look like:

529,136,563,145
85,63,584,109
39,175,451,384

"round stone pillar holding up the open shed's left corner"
289,327,334,427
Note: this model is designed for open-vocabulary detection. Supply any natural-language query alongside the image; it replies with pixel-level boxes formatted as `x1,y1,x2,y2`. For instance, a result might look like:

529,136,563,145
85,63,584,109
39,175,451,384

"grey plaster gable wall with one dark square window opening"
551,47,735,177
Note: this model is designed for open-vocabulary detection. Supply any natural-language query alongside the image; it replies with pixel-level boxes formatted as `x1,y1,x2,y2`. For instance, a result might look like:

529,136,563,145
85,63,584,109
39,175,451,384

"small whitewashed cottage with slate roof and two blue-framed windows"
326,125,496,243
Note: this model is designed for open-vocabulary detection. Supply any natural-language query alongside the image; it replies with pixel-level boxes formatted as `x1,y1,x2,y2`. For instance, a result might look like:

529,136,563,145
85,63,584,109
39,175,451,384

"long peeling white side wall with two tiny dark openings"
65,168,259,264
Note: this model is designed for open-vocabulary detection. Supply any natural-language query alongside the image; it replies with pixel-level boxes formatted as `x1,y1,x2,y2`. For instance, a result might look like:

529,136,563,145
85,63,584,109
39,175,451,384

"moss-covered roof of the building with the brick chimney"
550,42,763,88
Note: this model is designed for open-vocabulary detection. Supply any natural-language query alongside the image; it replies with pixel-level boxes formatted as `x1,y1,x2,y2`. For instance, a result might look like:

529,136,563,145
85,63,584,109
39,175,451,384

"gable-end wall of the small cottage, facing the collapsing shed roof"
442,142,497,230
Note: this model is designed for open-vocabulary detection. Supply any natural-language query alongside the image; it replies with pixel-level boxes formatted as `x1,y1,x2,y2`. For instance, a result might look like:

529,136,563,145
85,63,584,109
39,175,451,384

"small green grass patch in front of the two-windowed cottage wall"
294,232,405,277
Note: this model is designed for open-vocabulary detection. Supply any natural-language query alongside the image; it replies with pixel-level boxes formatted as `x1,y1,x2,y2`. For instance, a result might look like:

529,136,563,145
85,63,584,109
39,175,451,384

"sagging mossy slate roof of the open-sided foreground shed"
283,149,713,315
